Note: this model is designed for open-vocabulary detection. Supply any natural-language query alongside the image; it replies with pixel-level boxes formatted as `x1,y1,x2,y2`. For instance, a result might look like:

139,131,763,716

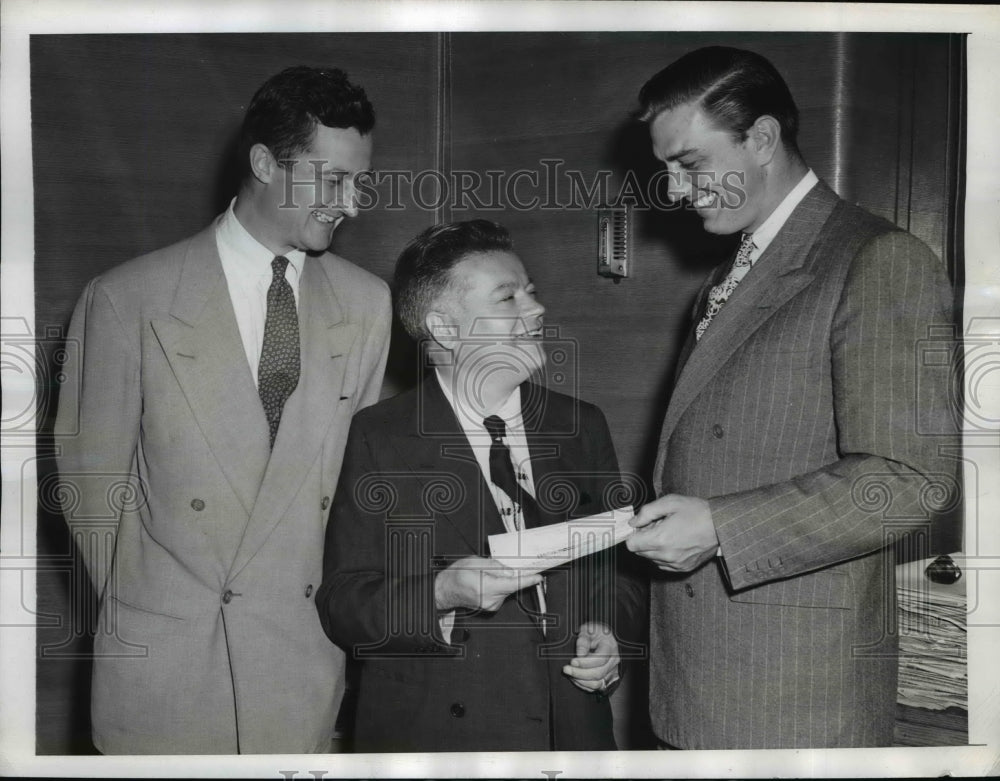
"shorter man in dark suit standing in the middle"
317,220,645,751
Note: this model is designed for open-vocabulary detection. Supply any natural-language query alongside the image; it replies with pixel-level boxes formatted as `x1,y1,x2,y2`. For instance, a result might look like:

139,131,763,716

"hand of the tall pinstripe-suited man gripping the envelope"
625,494,719,572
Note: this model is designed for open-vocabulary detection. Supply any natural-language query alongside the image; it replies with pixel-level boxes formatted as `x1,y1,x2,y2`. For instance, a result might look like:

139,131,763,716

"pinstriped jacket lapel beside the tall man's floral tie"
654,182,838,481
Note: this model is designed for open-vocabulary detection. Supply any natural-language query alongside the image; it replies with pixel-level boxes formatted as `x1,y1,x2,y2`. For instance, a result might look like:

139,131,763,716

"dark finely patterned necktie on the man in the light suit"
257,255,301,448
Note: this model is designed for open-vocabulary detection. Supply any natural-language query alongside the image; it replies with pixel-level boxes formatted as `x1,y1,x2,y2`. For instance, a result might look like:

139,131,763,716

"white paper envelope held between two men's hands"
489,506,635,572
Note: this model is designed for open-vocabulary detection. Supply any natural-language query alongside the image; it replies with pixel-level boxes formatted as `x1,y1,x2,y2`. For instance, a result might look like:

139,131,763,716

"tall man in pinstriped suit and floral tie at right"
628,47,958,749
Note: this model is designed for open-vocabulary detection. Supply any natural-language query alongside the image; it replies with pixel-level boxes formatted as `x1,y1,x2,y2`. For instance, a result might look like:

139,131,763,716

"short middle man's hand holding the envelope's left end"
434,556,542,612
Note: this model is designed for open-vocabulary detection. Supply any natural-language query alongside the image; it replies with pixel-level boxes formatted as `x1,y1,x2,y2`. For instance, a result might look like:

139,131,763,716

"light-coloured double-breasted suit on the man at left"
57,216,390,754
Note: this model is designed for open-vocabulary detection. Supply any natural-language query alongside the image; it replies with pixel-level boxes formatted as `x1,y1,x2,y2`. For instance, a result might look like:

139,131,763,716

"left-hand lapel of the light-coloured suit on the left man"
151,224,269,513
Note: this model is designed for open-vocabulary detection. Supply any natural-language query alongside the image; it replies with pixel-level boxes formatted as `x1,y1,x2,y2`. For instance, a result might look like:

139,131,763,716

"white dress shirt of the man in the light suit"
215,198,306,385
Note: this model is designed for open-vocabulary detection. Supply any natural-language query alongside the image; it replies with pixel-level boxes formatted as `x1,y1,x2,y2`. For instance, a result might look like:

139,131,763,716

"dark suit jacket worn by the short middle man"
317,375,645,751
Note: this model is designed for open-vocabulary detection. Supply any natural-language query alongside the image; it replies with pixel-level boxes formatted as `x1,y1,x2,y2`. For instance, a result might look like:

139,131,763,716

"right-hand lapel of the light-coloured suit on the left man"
230,258,358,578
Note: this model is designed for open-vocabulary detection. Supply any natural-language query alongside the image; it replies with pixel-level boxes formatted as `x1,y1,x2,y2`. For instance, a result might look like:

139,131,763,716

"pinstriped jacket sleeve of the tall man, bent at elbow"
710,231,958,589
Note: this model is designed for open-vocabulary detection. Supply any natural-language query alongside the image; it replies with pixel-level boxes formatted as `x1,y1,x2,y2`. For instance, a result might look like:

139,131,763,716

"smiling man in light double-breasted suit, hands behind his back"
56,67,390,754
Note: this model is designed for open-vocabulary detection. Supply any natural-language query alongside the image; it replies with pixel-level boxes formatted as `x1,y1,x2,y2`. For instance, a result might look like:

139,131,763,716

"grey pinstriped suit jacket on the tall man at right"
650,183,957,748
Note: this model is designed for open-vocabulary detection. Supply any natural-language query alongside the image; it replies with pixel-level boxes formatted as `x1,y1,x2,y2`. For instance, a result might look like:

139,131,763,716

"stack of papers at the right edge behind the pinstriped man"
896,554,968,710
